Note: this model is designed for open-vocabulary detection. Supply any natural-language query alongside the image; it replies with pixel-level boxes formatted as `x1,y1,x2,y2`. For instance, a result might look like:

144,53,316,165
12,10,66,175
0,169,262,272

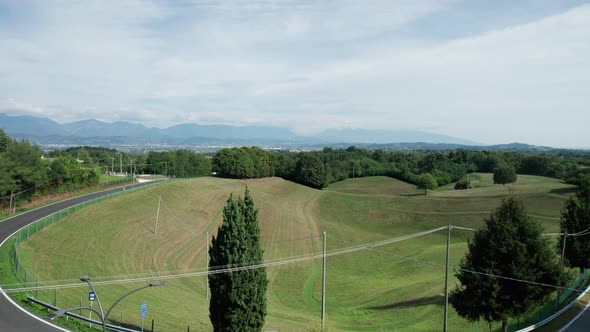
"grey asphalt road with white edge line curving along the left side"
0,182,162,332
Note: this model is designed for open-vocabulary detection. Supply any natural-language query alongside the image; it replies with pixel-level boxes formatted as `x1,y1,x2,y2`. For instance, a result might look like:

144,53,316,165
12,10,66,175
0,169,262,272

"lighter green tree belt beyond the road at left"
0,133,211,212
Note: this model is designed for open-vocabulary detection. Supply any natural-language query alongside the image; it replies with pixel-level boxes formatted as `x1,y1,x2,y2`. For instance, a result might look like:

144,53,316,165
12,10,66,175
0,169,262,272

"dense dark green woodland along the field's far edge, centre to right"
212,146,590,190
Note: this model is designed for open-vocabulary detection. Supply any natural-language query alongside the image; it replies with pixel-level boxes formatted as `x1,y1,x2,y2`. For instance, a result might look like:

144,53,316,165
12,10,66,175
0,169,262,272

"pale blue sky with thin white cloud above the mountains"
0,0,590,148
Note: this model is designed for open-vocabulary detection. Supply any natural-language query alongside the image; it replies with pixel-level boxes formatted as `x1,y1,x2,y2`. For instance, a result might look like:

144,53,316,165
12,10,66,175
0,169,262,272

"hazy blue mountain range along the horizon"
0,113,484,146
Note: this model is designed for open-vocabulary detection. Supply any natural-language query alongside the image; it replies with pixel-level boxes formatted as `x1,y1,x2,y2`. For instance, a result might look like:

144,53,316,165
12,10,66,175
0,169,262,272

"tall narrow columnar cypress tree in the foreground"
209,189,268,331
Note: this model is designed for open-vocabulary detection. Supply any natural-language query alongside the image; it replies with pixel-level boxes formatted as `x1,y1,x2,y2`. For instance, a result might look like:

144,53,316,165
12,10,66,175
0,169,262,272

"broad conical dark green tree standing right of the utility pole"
450,197,569,331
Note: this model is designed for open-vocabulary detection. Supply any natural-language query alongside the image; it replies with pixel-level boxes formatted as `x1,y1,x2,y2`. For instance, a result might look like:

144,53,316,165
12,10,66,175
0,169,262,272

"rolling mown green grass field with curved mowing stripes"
19,174,571,331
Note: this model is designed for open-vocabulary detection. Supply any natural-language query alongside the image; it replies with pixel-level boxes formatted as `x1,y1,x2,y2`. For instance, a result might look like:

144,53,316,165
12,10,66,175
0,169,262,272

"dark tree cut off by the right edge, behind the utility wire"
558,179,590,270
